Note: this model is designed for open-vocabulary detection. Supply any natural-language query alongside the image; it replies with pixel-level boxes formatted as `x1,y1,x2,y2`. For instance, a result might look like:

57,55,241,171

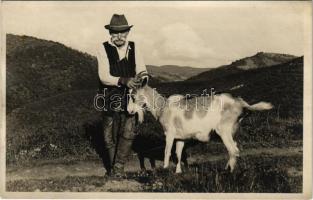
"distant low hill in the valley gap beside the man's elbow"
147,65,211,82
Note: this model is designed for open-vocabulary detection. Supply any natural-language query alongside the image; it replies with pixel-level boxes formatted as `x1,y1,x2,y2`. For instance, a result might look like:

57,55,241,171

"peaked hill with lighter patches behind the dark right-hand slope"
188,52,296,81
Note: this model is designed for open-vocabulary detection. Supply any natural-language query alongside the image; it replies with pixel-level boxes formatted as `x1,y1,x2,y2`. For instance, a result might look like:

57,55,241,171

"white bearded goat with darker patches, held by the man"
127,85,273,173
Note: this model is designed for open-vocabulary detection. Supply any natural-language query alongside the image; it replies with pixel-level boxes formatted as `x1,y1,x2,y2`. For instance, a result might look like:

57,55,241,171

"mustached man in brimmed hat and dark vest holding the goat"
97,14,148,175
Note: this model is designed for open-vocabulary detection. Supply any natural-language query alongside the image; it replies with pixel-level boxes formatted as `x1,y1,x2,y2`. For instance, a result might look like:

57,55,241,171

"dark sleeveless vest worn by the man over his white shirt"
99,41,136,114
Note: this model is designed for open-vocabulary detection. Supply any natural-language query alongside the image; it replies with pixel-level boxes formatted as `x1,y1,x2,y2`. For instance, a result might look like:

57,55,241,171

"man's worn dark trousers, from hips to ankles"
103,113,136,169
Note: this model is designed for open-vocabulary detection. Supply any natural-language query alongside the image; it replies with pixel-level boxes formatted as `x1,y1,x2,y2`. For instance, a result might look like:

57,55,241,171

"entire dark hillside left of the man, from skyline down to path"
6,34,100,162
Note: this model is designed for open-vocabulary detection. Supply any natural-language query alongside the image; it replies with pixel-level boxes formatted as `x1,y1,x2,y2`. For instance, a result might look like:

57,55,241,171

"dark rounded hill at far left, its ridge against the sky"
6,34,98,113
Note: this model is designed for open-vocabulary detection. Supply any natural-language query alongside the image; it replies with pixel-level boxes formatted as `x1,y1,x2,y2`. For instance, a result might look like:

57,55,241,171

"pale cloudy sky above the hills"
2,1,311,67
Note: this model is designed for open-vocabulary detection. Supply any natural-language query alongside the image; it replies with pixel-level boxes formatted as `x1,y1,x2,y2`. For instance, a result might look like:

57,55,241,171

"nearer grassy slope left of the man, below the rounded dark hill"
6,90,101,163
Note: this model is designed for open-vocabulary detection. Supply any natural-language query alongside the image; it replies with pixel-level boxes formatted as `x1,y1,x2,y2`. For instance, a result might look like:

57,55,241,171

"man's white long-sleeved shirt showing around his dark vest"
97,41,147,86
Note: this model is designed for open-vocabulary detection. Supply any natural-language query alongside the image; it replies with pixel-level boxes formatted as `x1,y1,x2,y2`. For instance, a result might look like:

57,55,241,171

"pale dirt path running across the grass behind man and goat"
6,147,302,181
